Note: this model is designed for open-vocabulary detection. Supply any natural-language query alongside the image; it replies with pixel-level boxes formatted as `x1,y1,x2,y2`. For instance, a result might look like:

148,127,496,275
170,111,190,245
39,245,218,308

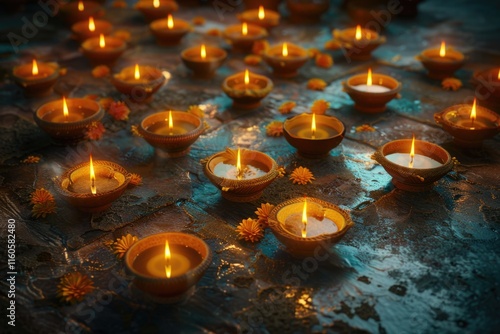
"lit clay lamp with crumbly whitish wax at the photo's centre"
202,149,279,202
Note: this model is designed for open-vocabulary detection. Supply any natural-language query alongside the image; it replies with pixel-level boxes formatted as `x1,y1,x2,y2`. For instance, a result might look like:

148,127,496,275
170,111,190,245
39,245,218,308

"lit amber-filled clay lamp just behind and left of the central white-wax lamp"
139,111,204,157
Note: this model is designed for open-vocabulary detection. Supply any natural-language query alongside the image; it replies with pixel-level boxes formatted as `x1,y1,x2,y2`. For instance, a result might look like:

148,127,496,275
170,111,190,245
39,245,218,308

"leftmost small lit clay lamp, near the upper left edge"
12,59,59,97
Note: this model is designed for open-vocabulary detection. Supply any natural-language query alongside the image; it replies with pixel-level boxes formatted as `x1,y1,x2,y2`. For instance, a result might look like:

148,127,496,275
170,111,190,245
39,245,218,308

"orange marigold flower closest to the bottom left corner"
57,271,94,302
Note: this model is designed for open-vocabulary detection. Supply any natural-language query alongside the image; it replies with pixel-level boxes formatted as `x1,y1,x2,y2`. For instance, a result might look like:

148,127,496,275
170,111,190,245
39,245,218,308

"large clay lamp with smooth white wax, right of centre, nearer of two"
372,137,453,192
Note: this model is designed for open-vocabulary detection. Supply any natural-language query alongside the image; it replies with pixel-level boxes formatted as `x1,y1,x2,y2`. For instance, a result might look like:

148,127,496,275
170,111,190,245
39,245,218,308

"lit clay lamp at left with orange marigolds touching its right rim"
34,97,104,143
